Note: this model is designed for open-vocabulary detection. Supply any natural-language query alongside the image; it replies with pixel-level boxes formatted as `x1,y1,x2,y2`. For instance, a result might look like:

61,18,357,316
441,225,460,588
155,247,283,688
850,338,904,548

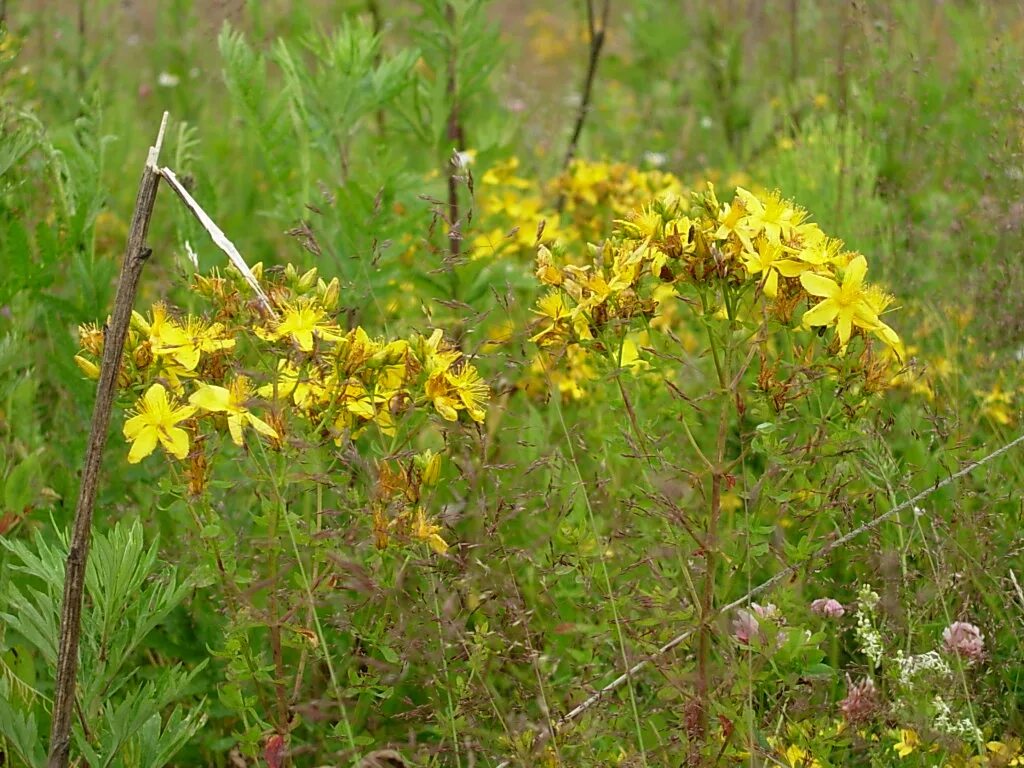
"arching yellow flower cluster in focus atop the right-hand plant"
532,184,901,366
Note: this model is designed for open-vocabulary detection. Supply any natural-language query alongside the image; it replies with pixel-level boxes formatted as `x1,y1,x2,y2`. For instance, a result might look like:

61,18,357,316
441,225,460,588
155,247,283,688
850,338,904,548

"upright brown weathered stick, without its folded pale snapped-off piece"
47,113,167,768
